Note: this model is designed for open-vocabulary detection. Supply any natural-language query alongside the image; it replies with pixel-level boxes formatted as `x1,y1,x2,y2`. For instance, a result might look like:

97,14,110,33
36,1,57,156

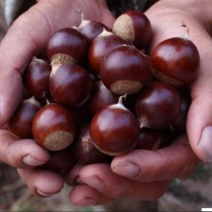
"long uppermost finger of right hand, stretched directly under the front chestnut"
111,137,198,182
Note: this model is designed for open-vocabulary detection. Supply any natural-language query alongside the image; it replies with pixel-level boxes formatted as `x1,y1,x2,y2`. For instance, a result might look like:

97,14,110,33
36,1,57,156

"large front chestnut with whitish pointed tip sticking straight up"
89,97,140,156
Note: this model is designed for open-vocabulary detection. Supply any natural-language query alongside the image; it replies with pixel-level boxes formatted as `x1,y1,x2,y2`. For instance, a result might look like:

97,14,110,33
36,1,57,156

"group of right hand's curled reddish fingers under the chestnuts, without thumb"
65,137,198,206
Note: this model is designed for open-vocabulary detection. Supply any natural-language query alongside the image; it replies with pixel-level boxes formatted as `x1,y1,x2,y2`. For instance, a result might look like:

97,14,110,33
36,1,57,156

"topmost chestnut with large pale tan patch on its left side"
112,10,153,49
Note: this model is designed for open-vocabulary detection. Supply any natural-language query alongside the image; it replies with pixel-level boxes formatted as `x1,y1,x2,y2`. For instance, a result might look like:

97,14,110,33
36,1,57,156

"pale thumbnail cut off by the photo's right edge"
199,126,212,162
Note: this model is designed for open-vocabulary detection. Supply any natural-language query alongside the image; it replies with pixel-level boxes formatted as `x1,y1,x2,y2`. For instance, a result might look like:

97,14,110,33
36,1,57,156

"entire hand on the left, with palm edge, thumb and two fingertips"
0,0,113,196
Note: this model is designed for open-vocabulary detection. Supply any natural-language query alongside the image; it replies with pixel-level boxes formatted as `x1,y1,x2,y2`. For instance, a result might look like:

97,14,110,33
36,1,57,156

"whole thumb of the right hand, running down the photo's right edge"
187,37,212,162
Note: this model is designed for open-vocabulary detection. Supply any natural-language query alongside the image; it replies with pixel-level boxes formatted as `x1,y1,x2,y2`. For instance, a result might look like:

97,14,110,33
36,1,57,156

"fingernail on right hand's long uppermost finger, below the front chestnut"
112,161,139,178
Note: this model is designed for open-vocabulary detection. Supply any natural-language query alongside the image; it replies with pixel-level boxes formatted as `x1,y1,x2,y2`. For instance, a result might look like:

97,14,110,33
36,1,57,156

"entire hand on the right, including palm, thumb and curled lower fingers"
62,0,212,205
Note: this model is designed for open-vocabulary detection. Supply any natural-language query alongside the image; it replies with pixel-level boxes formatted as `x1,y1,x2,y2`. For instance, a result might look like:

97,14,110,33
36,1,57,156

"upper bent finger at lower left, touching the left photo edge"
0,129,50,168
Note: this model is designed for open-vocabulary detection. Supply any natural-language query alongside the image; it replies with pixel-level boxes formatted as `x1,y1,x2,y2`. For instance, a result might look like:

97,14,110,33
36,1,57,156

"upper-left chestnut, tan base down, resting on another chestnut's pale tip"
46,28,88,65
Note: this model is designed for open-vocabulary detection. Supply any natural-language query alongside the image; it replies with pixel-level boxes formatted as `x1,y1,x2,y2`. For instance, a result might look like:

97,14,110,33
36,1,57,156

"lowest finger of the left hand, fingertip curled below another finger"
18,169,64,197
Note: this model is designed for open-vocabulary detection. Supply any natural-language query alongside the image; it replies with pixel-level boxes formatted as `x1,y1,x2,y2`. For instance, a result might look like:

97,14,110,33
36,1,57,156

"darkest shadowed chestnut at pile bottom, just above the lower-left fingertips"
41,147,76,174
